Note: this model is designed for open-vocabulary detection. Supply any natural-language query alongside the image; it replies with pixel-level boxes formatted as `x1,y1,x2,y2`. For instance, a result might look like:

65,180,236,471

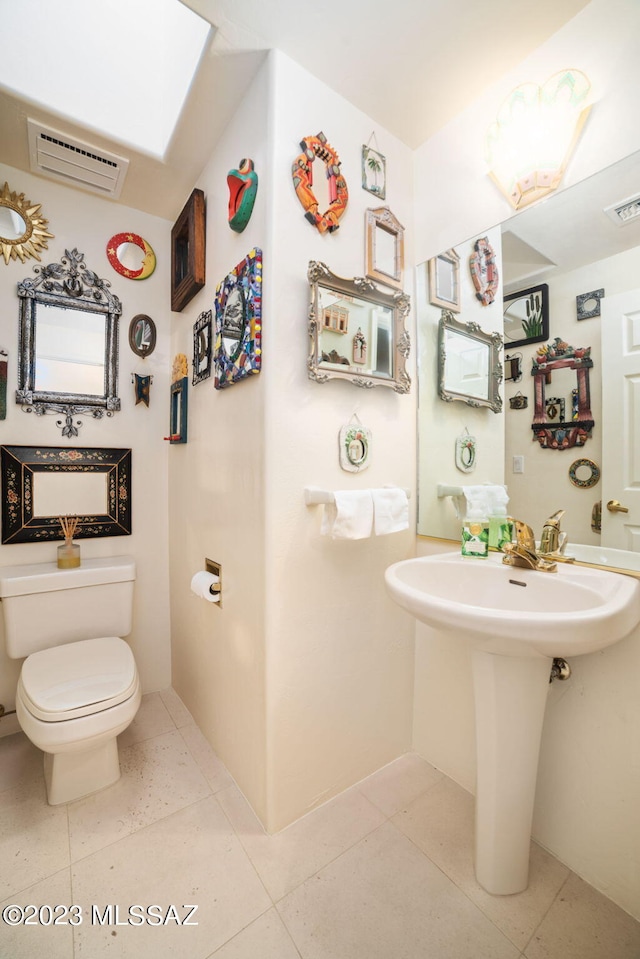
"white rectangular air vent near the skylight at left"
27,119,129,200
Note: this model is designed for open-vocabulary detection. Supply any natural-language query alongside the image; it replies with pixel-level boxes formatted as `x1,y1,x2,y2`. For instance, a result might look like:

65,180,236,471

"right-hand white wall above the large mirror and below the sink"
414,0,640,917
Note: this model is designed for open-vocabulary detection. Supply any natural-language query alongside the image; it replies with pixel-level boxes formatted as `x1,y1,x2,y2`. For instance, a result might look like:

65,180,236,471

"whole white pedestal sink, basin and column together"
385,553,640,895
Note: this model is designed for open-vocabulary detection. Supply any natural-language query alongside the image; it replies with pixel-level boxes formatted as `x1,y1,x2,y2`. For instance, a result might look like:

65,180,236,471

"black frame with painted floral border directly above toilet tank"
0,446,131,544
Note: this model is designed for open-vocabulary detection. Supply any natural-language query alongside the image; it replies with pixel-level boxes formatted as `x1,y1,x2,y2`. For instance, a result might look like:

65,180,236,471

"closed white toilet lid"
20,636,138,722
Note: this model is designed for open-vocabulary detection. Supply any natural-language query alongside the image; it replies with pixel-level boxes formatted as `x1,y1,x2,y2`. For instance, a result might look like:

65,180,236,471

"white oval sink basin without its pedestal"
385,553,640,658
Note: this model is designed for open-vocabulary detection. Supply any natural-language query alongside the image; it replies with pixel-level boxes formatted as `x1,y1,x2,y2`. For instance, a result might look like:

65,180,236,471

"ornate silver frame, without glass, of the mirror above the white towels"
307,260,411,393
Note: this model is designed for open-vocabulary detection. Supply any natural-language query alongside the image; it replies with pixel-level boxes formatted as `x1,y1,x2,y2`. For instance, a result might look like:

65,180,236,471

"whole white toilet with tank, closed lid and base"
0,556,141,806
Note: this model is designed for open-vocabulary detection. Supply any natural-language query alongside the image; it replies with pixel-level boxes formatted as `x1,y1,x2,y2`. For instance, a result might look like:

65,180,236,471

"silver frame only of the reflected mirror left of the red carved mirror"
438,310,503,413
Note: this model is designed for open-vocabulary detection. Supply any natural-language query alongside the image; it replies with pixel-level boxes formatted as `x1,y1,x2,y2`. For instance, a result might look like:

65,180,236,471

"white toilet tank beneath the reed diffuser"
0,556,136,659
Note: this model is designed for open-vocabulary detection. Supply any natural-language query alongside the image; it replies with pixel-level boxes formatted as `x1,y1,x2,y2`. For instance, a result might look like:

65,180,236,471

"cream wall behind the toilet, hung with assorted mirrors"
0,165,171,732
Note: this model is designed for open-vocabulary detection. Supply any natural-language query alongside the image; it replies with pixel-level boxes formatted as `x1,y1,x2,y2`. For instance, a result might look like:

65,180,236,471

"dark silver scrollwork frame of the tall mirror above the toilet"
16,249,122,438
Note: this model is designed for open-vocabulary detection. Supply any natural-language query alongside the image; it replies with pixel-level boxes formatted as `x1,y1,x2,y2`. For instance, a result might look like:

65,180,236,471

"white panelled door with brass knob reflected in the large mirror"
602,290,640,553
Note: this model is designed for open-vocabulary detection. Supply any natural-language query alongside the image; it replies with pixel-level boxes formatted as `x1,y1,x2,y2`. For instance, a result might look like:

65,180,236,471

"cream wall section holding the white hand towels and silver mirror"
265,54,416,829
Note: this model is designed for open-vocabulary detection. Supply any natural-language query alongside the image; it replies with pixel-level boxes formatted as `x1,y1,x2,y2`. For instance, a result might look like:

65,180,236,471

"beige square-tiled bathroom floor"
0,690,640,959
